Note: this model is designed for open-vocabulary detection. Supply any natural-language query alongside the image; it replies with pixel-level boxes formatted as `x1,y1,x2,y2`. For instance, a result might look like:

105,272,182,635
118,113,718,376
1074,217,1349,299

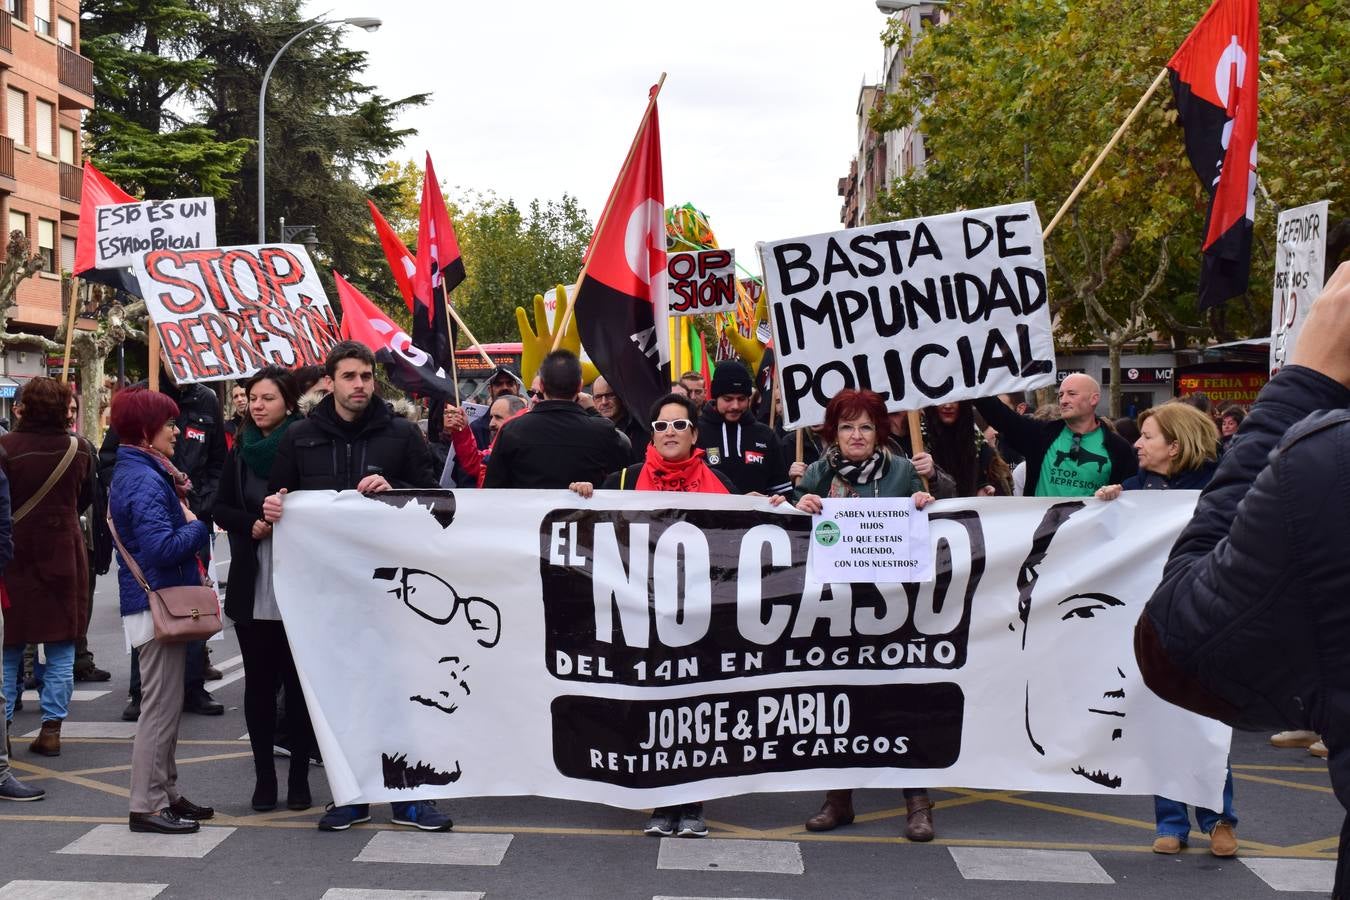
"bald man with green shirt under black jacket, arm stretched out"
975,372,1139,497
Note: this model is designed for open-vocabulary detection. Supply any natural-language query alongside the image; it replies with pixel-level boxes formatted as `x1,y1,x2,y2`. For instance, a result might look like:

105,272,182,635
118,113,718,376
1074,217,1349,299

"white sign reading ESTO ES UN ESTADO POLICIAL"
95,197,216,269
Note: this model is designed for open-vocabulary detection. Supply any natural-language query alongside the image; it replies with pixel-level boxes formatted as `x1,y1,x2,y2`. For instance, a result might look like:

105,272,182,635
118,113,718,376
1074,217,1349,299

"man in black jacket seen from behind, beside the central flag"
483,349,633,490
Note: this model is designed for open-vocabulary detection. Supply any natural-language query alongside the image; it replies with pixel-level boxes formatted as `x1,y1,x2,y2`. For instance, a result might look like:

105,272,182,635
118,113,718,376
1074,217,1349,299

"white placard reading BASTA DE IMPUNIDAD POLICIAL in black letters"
759,202,1054,430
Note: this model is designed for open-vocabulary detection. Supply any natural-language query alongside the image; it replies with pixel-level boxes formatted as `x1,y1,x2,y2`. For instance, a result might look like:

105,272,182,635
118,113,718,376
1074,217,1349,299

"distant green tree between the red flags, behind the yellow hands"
450,193,591,343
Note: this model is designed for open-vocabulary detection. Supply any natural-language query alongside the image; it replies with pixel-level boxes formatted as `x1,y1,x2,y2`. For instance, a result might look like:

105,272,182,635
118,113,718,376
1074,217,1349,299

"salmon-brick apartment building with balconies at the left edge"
0,0,93,414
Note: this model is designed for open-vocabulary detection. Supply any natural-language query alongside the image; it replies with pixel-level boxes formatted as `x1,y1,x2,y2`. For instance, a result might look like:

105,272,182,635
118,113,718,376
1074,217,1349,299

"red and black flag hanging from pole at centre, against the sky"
575,85,671,417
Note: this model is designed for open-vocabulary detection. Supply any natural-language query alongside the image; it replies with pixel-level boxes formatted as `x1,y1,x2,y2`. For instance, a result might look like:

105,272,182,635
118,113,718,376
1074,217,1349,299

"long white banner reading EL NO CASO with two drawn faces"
274,490,1230,808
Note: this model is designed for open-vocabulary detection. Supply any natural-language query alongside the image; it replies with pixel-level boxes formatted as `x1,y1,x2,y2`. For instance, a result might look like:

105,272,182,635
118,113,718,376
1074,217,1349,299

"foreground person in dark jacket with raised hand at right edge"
1134,263,1350,900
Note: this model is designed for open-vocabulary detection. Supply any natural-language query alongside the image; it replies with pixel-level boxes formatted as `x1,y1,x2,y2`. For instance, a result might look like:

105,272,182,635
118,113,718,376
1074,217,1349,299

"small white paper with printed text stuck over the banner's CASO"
811,498,933,583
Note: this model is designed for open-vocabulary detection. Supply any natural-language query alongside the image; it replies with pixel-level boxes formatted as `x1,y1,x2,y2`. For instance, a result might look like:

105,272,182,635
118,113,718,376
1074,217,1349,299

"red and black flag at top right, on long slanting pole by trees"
1168,0,1261,309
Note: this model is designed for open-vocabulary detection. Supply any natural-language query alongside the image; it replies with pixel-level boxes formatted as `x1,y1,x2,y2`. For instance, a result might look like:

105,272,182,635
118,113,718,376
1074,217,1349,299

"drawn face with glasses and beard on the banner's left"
373,567,501,788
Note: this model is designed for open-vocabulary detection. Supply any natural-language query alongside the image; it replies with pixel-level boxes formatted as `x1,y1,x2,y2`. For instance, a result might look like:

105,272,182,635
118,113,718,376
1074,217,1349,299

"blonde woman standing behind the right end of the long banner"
1096,401,1238,857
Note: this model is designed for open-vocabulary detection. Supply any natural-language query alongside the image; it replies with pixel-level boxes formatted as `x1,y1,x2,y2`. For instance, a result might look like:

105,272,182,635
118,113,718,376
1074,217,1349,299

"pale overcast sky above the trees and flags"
308,0,886,271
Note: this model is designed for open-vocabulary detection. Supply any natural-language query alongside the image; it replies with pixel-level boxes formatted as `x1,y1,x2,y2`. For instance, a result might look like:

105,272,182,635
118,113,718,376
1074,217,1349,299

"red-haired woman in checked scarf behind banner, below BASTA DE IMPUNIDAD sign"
770,390,933,841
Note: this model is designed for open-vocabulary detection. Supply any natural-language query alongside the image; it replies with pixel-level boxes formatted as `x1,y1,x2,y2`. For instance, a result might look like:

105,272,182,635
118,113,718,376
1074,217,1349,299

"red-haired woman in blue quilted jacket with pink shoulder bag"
108,387,215,834
